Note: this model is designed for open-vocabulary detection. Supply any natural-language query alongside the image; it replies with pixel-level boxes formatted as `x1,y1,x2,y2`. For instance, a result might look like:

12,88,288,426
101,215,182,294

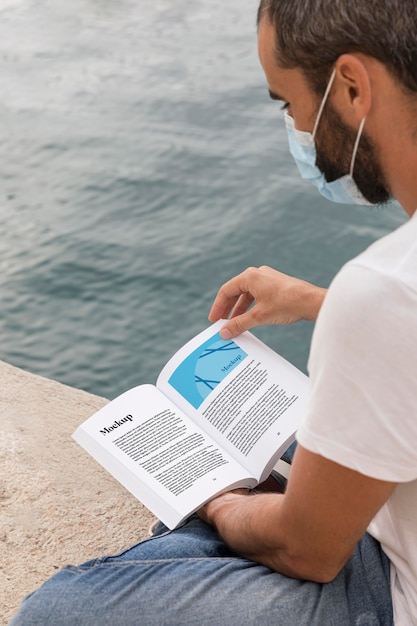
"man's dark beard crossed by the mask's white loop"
315,103,391,204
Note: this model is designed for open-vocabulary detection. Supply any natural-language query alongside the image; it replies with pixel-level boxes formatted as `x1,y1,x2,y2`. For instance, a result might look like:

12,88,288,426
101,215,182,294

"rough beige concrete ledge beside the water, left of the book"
0,361,154,626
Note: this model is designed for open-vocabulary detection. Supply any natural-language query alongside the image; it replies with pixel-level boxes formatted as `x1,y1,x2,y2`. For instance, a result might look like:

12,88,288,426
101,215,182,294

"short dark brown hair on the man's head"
258,0,417,93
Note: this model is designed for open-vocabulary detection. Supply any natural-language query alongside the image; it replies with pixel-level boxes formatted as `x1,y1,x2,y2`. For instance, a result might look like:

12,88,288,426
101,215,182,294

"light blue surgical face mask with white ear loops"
285,70,372,205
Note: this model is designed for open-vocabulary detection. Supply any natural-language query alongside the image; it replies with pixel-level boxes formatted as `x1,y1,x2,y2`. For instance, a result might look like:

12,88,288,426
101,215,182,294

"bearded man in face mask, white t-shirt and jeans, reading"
12,0,417,626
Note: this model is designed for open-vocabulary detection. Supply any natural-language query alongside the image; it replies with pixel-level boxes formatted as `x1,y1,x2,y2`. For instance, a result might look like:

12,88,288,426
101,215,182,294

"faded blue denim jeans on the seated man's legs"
10,516,393,626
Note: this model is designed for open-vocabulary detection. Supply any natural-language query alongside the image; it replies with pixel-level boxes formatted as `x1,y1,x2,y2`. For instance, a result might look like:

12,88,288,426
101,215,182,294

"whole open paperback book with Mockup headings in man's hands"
73,322,308,528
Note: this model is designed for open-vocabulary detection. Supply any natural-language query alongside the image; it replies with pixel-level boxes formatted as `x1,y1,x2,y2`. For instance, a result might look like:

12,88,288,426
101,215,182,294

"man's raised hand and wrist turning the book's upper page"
209,266,326,339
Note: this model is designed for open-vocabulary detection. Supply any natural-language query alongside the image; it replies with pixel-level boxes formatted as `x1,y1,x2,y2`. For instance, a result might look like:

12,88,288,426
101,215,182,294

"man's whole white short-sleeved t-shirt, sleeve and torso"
297,212,417,626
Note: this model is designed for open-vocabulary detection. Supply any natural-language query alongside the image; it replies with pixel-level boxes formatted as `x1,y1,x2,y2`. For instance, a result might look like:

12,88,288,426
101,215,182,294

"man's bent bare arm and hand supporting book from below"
199,446,395,582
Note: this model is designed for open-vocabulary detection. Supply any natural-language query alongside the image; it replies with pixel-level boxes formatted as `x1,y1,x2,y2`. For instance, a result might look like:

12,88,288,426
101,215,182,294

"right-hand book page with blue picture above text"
157,322,308,480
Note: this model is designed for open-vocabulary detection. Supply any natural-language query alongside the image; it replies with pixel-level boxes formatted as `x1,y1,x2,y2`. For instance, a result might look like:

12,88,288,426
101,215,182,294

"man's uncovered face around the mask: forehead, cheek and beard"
258,18,390,204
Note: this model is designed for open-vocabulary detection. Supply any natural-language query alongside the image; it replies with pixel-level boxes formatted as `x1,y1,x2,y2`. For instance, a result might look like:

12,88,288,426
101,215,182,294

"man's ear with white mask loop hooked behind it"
334,53,372,122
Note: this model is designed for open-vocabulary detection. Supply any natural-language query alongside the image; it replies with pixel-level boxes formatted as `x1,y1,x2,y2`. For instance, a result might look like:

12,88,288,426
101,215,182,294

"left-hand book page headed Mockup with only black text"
73,385,256,528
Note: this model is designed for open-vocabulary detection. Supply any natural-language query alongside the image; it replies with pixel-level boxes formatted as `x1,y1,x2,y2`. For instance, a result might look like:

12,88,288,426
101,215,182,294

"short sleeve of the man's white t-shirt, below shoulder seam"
297,263,417,482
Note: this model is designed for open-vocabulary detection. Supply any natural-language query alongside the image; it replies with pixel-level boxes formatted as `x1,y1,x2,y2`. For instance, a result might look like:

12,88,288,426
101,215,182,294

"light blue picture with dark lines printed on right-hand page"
168,333,248,409
